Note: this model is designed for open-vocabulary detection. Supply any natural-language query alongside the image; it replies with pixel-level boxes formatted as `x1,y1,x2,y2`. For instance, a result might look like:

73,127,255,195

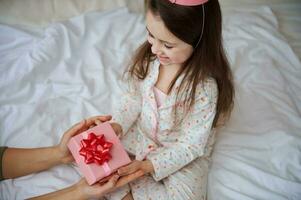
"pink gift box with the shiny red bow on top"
67,122,131,185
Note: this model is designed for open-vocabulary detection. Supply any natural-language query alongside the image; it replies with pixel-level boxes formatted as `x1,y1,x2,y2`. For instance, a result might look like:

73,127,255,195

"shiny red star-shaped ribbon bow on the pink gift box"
79,133,113,165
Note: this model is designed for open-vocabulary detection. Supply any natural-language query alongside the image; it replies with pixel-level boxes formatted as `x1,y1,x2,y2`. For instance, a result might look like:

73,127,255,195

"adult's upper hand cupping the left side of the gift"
54,116,111,164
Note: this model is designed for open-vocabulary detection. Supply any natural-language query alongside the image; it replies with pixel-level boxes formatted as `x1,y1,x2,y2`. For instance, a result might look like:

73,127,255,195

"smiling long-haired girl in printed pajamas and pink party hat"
106,0,234,200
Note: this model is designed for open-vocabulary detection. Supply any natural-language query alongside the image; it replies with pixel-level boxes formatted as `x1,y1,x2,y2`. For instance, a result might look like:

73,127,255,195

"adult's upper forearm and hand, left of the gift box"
2,116,111,179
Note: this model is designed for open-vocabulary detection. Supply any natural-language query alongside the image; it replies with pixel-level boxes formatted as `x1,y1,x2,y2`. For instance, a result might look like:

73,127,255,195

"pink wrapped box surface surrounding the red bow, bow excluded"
68,122,131,185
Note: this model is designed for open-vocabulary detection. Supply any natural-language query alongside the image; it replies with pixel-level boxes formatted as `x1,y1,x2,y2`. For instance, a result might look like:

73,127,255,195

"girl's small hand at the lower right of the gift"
117,160,154,176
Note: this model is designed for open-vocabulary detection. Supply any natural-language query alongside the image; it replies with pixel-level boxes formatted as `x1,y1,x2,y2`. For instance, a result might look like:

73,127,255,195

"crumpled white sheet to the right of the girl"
209,7,301,200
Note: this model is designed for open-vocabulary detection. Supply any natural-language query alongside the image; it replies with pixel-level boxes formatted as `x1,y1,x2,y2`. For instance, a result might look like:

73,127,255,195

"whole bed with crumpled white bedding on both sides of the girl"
0,0,301,200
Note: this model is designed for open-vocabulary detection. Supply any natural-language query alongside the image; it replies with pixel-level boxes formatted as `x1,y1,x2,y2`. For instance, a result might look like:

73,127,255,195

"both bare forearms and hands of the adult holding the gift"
0,116,142,200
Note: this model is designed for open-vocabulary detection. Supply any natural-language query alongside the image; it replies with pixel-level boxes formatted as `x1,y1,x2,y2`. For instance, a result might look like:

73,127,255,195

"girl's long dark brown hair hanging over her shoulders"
129,0,234,127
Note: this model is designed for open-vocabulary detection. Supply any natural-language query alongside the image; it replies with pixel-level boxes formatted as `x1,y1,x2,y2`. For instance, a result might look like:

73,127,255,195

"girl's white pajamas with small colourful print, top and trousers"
109,60,218,200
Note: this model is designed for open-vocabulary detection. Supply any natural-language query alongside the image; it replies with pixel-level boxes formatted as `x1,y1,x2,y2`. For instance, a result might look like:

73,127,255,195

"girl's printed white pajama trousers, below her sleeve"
130,158,208,200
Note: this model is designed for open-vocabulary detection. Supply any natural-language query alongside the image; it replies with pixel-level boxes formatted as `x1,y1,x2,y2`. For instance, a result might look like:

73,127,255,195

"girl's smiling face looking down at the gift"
146,11,193,66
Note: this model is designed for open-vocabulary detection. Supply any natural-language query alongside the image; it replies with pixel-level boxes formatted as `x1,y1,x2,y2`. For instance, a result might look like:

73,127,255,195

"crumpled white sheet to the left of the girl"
0,9,145,200
